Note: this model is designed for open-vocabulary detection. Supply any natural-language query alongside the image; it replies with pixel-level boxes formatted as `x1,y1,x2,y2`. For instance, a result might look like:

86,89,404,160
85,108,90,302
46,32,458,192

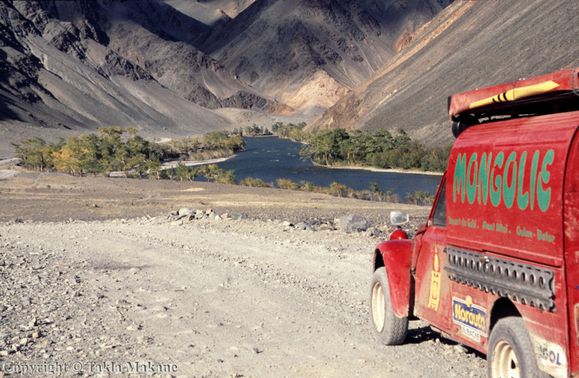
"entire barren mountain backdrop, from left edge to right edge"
5,0,579,153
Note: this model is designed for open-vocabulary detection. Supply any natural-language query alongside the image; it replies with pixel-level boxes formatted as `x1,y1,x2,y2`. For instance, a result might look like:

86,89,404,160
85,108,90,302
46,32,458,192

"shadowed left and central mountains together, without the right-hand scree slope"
0,0,451,152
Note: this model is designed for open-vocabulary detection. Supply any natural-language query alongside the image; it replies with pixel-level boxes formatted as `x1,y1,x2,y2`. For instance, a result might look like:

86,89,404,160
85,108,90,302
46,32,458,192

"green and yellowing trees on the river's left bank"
14,127,245,177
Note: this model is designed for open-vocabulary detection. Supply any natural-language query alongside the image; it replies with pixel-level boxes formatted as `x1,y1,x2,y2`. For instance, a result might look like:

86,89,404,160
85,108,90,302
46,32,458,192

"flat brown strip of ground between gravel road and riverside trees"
0,171,427,223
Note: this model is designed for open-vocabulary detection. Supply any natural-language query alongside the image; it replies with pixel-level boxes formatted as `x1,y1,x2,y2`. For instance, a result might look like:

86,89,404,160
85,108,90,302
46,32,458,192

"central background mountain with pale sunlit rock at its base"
202,0,450,115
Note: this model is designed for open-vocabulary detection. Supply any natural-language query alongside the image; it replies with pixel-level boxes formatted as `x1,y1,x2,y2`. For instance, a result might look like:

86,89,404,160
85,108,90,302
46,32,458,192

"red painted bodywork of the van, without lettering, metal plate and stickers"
379,70,579,376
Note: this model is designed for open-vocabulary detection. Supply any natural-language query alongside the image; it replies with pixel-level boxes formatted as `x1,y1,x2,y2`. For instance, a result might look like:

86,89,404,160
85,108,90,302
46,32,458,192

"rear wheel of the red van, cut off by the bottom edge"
487,316,546,378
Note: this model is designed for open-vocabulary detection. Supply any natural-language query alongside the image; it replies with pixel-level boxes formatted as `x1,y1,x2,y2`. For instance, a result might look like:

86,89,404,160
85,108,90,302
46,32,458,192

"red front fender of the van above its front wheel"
376,239,413,317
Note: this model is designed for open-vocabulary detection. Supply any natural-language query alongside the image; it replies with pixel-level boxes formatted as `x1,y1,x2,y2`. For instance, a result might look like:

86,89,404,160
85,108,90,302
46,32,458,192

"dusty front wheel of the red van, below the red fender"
370,267,408,345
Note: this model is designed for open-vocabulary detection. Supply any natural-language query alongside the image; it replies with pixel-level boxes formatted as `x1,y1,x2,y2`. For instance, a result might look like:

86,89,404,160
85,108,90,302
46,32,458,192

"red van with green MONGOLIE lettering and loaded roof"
370,69,579,377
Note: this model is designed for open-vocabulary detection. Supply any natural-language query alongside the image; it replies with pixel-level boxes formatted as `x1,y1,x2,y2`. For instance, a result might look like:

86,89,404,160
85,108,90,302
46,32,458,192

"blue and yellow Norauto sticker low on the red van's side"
452,295,487,343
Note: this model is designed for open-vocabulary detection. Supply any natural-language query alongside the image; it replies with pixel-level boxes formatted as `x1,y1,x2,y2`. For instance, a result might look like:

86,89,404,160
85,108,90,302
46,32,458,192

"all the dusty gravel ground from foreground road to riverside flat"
0,170,486,377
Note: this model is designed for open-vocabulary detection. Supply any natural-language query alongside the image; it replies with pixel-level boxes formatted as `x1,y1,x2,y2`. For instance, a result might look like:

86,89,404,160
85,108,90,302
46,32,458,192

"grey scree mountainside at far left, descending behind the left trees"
0,0,230,139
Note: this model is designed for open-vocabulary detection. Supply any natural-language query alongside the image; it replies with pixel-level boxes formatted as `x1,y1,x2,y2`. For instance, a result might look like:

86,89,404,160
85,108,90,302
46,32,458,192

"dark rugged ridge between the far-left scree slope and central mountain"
99,0,279,111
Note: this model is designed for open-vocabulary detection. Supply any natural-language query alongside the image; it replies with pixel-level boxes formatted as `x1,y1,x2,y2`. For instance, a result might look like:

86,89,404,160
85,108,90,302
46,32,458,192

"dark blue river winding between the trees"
218,137,441,198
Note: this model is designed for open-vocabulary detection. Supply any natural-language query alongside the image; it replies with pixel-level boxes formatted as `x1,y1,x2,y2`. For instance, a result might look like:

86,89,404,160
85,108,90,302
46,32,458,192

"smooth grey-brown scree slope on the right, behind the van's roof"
310,0,579,143
